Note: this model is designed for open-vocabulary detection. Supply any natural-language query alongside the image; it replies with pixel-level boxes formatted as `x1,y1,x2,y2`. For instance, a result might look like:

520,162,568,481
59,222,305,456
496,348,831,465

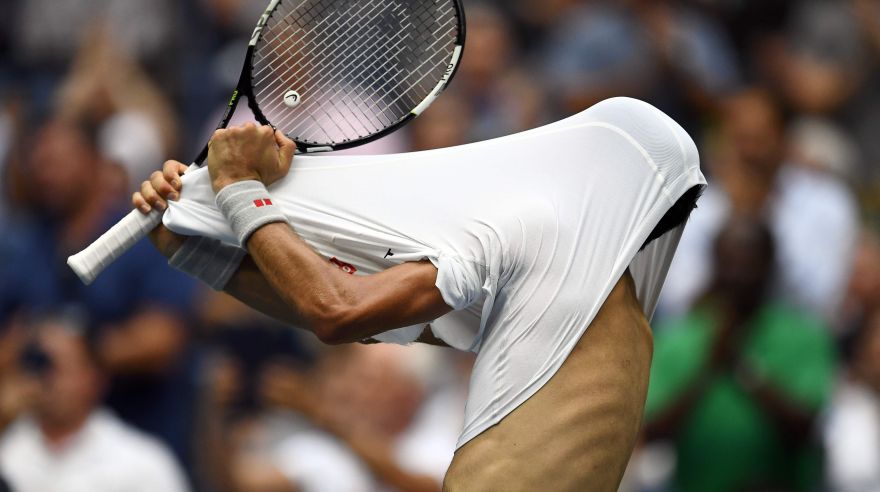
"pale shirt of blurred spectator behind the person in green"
661,165,858,321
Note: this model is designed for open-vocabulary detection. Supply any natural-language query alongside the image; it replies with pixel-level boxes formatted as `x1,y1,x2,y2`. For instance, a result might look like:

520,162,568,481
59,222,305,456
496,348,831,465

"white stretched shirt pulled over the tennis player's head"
165,98,706,446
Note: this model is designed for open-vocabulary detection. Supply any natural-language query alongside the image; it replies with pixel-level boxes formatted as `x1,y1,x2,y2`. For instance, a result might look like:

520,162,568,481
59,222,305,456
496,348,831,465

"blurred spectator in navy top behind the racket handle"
0,114,194,468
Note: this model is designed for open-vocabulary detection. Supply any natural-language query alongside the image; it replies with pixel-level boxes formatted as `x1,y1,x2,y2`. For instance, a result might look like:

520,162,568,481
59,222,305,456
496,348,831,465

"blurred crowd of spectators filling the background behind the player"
0,0,880,492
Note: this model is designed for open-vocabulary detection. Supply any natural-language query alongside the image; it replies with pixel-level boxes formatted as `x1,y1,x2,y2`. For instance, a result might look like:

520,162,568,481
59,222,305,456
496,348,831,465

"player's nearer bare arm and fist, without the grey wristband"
208,125,450,343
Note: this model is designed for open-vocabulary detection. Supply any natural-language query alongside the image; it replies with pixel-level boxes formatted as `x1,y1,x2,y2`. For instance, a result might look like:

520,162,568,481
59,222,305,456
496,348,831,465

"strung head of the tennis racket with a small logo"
251,0,460,145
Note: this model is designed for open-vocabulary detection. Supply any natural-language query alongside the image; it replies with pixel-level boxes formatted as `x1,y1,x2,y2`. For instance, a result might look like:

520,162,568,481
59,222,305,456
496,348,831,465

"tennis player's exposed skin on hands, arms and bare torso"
133,125,652,491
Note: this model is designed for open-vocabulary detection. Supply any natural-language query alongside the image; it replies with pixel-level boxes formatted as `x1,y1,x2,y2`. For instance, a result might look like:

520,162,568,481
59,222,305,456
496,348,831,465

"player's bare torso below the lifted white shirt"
444,271,653,492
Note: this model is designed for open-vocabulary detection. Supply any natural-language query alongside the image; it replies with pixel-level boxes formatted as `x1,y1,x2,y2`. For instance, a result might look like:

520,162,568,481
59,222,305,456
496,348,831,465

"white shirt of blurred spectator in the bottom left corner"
0,411,188,492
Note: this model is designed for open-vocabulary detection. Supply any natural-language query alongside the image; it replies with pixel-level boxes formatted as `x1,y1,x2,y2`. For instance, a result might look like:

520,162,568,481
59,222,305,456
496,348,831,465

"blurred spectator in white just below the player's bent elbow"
265,345,464,491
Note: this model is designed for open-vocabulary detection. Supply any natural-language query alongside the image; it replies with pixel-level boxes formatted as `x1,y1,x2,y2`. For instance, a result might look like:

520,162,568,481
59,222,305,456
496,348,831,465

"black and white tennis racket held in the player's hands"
67,0,465,284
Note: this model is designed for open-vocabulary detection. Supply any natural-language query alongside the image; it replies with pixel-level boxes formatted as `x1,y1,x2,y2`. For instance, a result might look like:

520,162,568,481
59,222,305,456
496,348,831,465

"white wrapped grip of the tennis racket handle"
67,209,162,285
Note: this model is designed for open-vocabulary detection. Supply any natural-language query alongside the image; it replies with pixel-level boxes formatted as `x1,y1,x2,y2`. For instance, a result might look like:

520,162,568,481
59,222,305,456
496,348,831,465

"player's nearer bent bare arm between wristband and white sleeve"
241,223,451,344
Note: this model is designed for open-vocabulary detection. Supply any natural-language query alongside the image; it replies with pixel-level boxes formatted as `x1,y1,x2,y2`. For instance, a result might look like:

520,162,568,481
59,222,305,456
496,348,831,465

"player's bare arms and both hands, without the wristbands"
142,125,450,343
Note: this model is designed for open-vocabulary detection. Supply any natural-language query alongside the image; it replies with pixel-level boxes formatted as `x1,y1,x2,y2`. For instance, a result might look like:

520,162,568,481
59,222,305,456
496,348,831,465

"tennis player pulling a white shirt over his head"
133,98,706,491
